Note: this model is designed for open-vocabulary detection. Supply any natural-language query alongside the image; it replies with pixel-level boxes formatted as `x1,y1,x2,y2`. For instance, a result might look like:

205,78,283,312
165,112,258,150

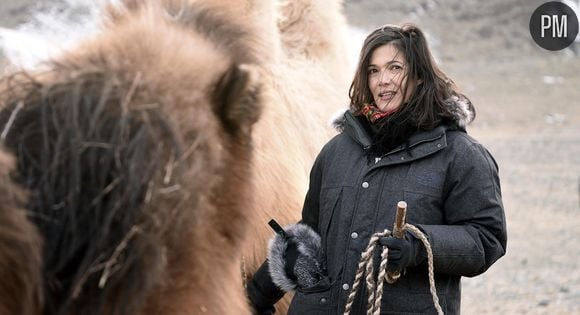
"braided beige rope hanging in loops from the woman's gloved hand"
343,224,443,315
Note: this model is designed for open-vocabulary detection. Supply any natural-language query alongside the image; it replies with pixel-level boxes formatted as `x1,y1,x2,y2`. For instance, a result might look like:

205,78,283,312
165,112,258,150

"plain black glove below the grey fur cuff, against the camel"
247,261,284,315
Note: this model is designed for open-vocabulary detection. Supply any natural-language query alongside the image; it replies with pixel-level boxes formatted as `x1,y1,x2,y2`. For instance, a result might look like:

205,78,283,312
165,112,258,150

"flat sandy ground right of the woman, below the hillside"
462,58,580,314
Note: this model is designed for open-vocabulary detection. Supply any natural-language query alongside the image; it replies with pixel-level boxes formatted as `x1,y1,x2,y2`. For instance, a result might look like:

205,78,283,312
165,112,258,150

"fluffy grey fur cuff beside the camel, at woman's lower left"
268,223,326,292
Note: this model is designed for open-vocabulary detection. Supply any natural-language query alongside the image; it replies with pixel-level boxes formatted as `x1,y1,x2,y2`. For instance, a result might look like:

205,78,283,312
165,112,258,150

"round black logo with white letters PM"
530,1,578,51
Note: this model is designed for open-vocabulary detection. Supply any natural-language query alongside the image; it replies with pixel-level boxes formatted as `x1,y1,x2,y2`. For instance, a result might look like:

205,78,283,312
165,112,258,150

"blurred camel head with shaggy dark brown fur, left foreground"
0,1,261,314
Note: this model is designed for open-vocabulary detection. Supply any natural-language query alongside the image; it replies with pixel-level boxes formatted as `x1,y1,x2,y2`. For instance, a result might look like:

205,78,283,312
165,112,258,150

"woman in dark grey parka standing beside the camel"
248,25,506,314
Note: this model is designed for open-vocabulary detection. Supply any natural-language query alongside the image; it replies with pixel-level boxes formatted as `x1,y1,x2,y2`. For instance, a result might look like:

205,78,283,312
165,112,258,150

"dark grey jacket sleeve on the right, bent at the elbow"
418,143,507,277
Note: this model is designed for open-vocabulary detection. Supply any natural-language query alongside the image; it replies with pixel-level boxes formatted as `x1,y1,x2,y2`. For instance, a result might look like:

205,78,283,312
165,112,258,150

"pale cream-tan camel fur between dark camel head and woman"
236,0,351,314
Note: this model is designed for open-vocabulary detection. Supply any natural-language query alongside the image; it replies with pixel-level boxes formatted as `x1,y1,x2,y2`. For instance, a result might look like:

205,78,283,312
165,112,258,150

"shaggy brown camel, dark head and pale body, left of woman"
0,0,347,314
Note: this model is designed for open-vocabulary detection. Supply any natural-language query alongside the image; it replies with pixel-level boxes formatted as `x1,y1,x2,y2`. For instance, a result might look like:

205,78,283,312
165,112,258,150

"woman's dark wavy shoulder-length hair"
349,24,465,130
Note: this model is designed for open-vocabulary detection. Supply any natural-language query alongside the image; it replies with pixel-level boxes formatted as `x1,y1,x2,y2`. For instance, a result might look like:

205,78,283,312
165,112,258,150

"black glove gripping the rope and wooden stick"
379,232,425,271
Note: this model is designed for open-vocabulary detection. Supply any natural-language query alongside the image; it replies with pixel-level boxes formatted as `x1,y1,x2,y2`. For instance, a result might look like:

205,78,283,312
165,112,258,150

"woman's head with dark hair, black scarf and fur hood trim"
350,25,475,156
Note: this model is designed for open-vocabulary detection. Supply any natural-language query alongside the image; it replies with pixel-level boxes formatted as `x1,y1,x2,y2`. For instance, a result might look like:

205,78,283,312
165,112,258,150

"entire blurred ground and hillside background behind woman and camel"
0,0,580,314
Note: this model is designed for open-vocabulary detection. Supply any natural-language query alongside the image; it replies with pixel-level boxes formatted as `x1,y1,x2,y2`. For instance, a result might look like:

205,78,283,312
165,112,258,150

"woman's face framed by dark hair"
367,44,416,111
